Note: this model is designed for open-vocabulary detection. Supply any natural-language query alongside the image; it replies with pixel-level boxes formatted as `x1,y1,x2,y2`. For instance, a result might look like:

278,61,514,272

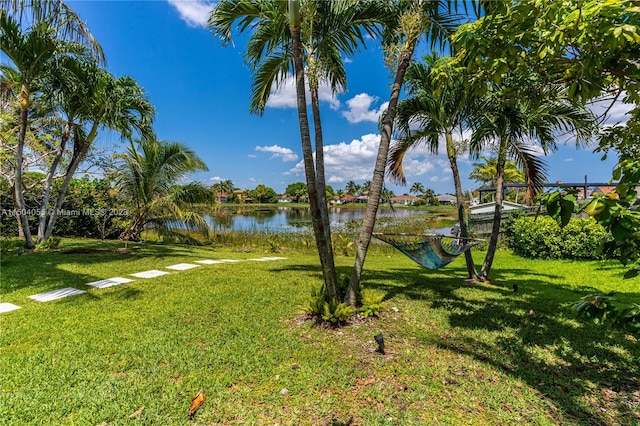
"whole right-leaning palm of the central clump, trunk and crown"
345,0,457,306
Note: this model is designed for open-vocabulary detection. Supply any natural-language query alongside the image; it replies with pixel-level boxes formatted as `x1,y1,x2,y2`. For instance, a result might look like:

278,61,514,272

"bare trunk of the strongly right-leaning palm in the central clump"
345,45,417,307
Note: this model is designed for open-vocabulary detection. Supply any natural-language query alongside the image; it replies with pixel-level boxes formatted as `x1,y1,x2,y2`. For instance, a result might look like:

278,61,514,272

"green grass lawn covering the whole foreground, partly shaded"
0,240,640,425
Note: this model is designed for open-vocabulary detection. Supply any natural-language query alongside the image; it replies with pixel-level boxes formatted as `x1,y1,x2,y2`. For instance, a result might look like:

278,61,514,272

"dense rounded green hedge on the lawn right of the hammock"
507,216,607,259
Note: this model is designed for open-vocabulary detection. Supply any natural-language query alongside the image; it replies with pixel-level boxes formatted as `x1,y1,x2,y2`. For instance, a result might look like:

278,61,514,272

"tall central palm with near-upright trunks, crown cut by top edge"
210,0,384,298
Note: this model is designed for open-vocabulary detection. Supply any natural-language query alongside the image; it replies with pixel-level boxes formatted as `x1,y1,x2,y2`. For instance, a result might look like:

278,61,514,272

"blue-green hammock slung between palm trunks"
373,233,483,269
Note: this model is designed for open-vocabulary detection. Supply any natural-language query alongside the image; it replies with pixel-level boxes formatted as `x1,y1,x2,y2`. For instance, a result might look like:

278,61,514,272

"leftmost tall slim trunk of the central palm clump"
289,5,340,300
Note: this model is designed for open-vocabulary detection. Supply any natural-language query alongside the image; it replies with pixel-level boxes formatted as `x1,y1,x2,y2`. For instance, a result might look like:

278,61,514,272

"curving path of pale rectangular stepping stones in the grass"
0,256,286,313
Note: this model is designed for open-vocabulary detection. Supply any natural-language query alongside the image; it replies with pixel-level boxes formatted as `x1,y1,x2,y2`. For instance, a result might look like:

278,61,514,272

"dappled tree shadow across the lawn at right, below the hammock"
366,268,640,424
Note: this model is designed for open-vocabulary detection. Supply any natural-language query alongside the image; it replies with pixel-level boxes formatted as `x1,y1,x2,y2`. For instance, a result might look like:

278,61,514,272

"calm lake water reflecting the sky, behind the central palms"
207,207,425,232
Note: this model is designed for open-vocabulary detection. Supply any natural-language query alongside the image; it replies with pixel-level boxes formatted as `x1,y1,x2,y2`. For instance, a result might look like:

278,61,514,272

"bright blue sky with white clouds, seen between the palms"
60,0,625,194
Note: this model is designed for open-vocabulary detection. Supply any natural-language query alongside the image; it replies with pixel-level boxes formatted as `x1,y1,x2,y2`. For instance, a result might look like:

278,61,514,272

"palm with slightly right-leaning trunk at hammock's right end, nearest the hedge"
471,80,595,280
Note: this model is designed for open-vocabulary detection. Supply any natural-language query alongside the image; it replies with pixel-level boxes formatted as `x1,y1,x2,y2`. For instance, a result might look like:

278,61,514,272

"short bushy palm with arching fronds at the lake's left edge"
117,138,213,242
